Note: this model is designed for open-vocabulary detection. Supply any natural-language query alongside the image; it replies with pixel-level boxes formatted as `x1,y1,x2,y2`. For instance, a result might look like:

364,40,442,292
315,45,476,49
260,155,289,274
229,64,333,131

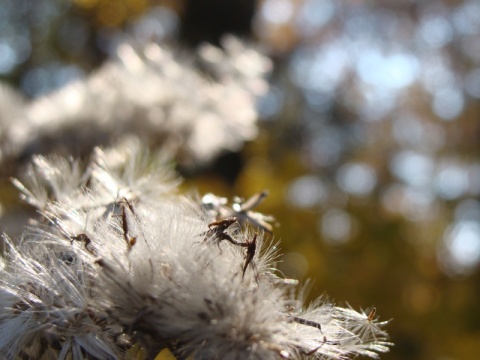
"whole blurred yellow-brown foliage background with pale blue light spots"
0,0,480,359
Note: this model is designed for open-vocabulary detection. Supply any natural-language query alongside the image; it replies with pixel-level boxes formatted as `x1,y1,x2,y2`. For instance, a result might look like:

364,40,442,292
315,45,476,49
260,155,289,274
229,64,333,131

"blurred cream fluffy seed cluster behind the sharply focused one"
0,36,271,170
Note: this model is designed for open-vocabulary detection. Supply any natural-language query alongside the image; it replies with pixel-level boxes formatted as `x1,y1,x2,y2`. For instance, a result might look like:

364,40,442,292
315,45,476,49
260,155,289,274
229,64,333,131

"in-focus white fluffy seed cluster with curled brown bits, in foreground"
0,149,390,360
